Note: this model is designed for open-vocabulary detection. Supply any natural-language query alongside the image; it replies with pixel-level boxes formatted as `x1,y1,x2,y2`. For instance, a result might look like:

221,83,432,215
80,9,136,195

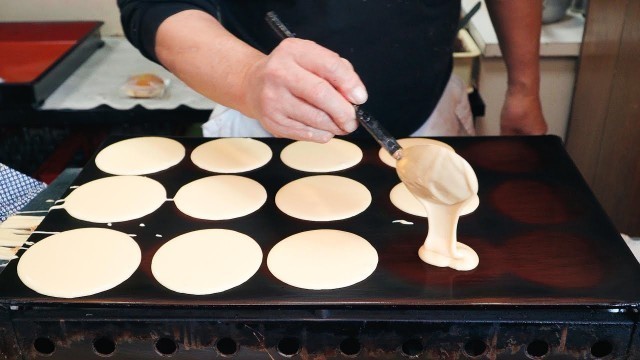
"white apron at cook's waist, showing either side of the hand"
202,75,476,137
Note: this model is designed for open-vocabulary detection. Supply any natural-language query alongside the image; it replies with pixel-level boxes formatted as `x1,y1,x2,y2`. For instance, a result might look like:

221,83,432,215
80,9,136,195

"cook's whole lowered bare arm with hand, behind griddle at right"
486,0,547,135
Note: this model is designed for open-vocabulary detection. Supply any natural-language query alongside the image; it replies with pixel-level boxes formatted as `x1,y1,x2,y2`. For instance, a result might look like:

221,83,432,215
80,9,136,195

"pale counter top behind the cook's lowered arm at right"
462,0,584,57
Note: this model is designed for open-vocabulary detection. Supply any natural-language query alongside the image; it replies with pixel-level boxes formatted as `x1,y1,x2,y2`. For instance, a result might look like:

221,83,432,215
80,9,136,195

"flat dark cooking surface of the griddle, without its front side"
0,136,640,309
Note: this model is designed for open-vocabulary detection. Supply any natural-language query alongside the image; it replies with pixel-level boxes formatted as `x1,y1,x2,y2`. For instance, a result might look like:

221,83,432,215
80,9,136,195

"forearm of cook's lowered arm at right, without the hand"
486,0,542,96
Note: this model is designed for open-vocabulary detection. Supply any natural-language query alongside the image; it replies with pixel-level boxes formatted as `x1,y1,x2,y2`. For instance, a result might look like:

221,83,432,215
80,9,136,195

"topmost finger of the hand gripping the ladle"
295,41,368,104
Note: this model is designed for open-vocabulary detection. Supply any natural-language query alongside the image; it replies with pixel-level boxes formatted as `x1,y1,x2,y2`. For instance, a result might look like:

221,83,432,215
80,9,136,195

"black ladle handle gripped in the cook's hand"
265,11,402,160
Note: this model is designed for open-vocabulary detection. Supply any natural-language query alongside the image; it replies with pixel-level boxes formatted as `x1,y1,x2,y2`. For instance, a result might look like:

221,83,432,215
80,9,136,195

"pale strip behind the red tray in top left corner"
0,0,122,36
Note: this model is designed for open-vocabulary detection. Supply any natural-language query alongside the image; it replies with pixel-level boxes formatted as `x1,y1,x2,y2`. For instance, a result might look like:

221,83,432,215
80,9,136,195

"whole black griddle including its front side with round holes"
0,136,640,359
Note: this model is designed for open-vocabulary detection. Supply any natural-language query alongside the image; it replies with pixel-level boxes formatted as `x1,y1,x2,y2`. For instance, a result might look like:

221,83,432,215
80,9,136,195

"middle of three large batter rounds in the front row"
151,229,262,295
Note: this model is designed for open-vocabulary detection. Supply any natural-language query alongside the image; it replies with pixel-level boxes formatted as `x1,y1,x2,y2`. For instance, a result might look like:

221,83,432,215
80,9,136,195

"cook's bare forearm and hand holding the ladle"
155,10,367,142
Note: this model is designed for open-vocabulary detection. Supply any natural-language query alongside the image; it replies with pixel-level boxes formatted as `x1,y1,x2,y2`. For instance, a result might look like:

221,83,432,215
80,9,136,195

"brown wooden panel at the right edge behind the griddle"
567,0,640,233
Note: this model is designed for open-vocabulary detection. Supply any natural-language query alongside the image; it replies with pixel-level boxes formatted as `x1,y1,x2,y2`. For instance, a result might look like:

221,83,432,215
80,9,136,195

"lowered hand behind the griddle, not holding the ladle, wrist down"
500,92,547,135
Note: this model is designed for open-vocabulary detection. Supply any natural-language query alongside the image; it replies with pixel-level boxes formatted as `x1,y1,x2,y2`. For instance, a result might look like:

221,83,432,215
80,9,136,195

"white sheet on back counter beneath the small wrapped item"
42,37,216,110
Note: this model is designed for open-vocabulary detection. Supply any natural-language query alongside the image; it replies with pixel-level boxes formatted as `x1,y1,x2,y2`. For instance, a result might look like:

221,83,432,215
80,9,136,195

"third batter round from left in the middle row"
275,175,371,221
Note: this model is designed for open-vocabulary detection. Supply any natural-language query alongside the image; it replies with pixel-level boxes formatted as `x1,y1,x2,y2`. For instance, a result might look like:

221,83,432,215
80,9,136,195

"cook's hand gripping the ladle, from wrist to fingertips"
243,38,367,142
